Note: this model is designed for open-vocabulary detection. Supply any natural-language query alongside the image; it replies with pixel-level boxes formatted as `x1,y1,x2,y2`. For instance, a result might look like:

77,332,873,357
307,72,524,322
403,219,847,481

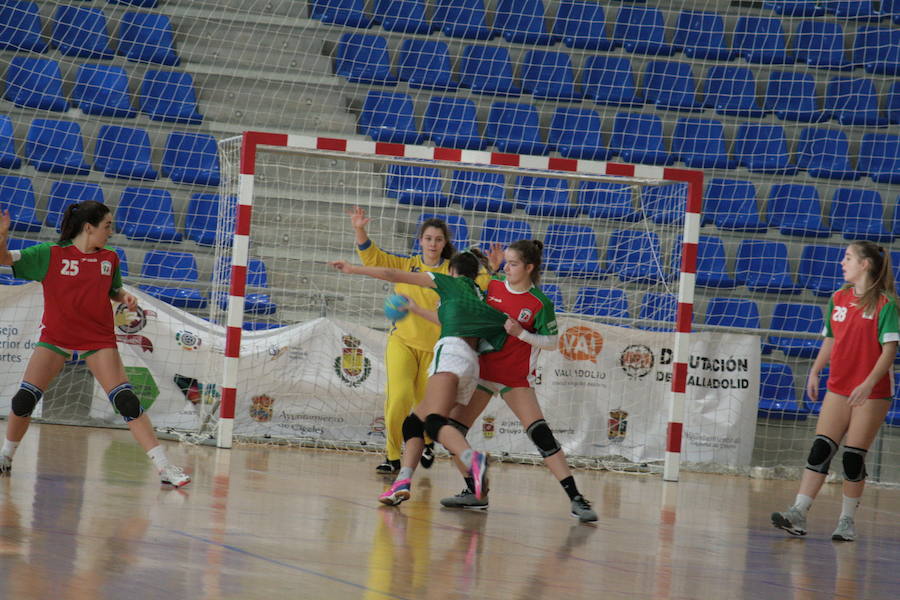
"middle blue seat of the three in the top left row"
50,6,115,58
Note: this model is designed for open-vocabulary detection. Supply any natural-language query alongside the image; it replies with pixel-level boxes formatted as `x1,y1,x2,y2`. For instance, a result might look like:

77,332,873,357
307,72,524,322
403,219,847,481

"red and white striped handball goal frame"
216,132,703,481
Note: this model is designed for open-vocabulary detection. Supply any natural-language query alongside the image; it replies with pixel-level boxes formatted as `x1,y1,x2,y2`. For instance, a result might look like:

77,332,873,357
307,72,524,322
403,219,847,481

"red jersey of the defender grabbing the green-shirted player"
479,278,557,387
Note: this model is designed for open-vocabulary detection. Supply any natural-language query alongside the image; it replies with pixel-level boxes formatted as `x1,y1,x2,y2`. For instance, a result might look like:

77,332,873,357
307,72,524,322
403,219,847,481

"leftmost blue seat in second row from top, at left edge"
3,56,69,112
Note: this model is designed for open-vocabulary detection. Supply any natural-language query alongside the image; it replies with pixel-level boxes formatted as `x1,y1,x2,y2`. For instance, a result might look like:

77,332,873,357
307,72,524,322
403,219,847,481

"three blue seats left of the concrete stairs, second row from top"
3,56,203,125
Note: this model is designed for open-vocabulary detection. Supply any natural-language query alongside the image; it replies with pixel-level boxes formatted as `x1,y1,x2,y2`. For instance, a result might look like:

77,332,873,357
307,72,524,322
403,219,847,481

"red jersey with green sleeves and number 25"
13,242,122,350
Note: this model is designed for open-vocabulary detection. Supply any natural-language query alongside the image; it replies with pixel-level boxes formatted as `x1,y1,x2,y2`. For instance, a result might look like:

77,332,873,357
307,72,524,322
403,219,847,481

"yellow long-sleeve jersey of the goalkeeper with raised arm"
356,240,490,352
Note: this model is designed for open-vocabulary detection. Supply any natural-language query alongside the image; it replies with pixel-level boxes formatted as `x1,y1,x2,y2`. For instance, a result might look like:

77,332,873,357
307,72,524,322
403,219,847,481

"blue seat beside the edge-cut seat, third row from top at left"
25,119,91,175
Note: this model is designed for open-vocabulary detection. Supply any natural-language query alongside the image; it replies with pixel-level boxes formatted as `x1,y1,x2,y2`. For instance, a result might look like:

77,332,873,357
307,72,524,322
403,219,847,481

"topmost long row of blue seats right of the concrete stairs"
310,0,900,74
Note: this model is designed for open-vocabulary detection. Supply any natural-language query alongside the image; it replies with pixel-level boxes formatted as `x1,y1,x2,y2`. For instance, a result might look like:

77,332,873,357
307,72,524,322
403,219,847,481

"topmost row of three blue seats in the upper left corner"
0,0,179,66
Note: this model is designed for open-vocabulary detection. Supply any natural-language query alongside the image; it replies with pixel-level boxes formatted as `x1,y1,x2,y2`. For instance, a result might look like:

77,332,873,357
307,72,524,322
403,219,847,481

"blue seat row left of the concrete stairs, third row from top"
0,115,220,185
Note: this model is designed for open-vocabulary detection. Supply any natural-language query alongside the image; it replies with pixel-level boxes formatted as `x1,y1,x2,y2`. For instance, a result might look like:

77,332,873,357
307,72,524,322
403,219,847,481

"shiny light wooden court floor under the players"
0,425,900,600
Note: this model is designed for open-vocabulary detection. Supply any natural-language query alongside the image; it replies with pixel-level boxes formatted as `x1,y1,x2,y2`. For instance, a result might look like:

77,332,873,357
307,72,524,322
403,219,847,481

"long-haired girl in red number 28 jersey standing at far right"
772,242,900,542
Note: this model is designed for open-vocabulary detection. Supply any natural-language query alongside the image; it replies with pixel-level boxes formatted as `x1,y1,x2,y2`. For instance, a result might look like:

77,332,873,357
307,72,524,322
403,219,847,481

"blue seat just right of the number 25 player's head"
115,187,181,243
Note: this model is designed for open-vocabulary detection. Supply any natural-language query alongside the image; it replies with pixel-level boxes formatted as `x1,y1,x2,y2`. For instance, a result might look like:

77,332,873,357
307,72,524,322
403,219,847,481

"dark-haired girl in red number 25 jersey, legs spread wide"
0,201,191,487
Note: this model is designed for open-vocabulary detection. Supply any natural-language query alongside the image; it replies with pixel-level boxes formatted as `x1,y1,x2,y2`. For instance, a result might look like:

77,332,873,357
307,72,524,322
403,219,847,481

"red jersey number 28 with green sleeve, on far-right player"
824,287,900,398
